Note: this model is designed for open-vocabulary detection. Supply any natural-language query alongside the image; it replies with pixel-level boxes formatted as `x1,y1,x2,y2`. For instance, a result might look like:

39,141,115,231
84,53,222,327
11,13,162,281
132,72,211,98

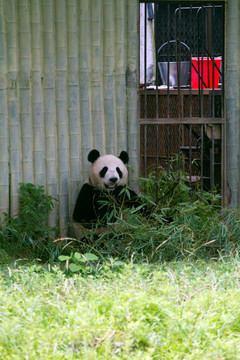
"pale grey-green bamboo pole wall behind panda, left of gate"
0,0,139,234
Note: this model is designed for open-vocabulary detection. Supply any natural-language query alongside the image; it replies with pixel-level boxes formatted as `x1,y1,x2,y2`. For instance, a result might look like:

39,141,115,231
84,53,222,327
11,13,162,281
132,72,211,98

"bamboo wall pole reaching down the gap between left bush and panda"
55,0,69,235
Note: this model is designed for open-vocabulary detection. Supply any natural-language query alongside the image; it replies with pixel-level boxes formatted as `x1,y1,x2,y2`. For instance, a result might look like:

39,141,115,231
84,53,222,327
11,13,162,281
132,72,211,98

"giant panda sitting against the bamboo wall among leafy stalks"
73,149,141,227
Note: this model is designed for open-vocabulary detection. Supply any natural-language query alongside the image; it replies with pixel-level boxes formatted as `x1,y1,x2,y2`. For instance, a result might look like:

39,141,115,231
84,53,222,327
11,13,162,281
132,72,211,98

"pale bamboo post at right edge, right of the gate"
226,0,240,208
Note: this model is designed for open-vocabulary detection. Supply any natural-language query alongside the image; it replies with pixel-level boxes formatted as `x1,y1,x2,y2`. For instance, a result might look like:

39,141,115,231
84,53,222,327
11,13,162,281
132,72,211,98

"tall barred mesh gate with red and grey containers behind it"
139,1,225,192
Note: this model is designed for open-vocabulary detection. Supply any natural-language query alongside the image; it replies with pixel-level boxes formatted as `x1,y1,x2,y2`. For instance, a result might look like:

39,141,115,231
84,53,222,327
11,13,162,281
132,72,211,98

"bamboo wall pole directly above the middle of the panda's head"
103,0,117,154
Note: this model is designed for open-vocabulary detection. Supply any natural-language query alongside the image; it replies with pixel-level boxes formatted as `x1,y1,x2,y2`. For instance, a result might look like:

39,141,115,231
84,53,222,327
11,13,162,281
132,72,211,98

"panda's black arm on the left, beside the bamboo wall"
73,184,97,224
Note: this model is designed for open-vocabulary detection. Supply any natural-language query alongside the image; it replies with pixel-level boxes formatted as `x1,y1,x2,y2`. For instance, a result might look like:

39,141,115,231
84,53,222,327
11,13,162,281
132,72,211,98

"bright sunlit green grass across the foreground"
0,258,240,360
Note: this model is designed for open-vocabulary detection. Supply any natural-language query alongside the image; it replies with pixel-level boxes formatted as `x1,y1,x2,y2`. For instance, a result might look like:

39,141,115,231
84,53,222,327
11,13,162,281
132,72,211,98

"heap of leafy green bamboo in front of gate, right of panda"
72,169,240,262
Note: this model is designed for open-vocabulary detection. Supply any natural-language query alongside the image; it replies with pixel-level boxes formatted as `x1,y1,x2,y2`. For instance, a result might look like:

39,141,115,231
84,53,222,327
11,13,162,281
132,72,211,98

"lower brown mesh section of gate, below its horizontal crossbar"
140,123,222,191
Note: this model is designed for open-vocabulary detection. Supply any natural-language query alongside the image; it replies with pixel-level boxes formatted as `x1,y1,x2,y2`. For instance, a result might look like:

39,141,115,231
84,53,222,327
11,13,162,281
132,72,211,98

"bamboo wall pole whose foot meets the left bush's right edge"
42,0,58,225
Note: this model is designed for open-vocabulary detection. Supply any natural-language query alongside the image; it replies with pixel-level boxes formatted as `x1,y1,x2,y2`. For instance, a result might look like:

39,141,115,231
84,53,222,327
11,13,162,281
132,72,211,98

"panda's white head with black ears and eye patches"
88,149,128,191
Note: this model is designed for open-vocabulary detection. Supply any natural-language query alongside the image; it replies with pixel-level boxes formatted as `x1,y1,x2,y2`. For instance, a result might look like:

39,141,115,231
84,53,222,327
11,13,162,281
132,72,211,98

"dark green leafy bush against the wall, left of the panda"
0,183,56,257
